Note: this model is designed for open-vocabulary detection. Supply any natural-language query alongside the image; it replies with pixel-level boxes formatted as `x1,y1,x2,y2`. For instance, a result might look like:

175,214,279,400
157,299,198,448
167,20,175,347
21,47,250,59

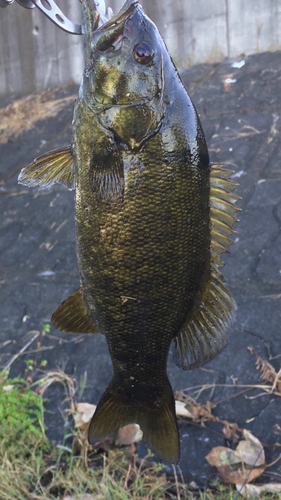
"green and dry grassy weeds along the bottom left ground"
0,370,280,500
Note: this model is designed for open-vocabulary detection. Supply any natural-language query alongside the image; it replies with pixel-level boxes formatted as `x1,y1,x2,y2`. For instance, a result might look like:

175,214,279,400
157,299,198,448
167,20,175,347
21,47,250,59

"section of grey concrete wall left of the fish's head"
0,0,84,96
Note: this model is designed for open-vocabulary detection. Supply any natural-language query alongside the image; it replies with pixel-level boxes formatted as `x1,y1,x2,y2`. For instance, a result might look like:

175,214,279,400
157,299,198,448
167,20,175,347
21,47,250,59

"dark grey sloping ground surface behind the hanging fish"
0,52,281,484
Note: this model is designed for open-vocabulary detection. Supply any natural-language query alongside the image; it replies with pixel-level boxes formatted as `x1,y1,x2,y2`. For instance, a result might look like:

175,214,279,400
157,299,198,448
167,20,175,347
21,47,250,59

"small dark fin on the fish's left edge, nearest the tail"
52,286,99,333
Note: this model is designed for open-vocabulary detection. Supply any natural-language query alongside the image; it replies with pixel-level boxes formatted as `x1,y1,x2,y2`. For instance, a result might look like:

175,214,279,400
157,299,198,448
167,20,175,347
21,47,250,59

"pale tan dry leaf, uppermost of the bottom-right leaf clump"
235,430,265,467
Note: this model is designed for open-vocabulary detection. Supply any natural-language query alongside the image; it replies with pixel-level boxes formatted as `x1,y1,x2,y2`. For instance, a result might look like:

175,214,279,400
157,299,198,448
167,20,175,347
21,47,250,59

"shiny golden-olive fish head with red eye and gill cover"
83,0,168,149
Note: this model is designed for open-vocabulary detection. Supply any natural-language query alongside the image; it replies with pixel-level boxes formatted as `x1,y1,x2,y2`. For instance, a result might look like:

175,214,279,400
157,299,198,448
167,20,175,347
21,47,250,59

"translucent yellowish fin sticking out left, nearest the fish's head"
19,146,75,189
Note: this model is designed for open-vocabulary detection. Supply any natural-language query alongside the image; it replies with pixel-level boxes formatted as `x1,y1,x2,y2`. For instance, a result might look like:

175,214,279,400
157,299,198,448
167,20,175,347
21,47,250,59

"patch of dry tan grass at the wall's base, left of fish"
0,88,76,144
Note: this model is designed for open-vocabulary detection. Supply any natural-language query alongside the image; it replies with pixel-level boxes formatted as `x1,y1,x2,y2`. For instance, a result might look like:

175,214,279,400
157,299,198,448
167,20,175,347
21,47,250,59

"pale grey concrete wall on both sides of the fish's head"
0,0,281,96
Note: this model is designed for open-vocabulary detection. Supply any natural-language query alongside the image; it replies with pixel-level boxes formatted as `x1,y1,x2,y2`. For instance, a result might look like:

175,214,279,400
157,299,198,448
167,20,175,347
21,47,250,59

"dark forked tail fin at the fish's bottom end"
88,381,180,463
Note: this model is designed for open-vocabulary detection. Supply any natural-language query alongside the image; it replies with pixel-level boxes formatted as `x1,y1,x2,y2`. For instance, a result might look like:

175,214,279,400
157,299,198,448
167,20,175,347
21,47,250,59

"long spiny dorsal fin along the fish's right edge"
174,165,240,370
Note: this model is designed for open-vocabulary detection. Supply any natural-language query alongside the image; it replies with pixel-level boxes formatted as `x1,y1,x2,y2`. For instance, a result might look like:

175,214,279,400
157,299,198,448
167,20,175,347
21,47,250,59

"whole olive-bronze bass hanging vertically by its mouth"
19,0,239,463
